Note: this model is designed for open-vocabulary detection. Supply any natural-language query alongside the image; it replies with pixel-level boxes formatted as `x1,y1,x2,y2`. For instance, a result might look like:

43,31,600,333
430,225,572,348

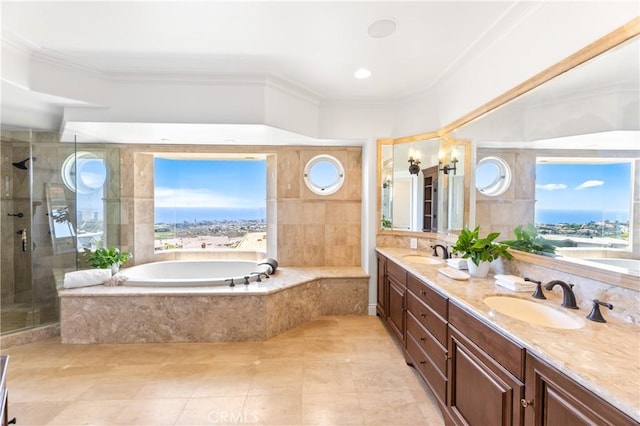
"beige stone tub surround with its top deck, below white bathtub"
59,267,369,344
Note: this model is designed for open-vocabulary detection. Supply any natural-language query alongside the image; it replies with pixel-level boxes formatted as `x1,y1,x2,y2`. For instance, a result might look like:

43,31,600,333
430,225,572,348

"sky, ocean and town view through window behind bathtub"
154,155,267,251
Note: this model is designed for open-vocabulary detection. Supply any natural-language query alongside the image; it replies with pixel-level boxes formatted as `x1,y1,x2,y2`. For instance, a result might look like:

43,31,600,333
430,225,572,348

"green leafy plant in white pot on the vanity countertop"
451,226,513,277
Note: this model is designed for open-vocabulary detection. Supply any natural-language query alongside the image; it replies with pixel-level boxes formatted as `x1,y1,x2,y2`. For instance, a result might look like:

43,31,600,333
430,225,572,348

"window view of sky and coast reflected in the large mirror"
535,158,633,253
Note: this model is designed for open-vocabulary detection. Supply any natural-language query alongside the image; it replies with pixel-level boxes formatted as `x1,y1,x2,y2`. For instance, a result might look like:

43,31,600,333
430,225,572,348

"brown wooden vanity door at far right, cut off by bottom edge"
523,354,638,426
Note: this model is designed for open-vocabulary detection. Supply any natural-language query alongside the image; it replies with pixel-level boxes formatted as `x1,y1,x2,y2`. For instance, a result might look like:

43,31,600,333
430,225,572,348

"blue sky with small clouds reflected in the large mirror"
536,162,631,211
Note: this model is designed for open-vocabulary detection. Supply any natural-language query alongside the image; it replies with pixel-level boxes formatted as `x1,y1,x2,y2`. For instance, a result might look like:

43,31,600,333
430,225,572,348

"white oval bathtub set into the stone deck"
116,260,277,287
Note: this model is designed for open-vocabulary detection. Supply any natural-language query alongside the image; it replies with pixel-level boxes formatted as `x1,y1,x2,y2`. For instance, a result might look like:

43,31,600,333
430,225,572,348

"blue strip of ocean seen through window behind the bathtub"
154,207,266,223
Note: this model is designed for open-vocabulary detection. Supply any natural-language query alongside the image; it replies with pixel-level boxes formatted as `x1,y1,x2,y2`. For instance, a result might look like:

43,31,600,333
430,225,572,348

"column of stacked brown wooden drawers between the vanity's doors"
405,274,448,407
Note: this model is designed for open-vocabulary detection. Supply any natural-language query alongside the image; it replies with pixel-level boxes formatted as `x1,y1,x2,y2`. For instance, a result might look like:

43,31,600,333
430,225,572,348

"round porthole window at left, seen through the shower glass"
61,151,107,194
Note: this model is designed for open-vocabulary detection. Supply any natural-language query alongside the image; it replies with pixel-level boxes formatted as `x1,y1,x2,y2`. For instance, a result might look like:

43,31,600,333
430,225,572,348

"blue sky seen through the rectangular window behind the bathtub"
154,158,267,208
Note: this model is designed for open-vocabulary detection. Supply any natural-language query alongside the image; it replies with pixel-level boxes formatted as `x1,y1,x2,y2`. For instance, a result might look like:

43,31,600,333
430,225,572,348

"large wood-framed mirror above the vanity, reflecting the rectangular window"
378,20,640,288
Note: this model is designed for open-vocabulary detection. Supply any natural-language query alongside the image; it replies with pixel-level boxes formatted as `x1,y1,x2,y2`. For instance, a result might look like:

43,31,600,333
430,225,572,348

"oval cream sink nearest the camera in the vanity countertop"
484,296,584,330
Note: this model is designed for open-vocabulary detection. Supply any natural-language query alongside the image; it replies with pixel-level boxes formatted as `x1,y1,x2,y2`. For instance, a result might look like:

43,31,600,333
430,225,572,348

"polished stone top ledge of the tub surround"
58,267,369,297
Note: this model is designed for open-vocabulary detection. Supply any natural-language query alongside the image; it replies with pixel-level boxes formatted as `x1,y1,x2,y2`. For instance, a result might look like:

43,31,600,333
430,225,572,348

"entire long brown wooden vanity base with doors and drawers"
376,254,638,426
